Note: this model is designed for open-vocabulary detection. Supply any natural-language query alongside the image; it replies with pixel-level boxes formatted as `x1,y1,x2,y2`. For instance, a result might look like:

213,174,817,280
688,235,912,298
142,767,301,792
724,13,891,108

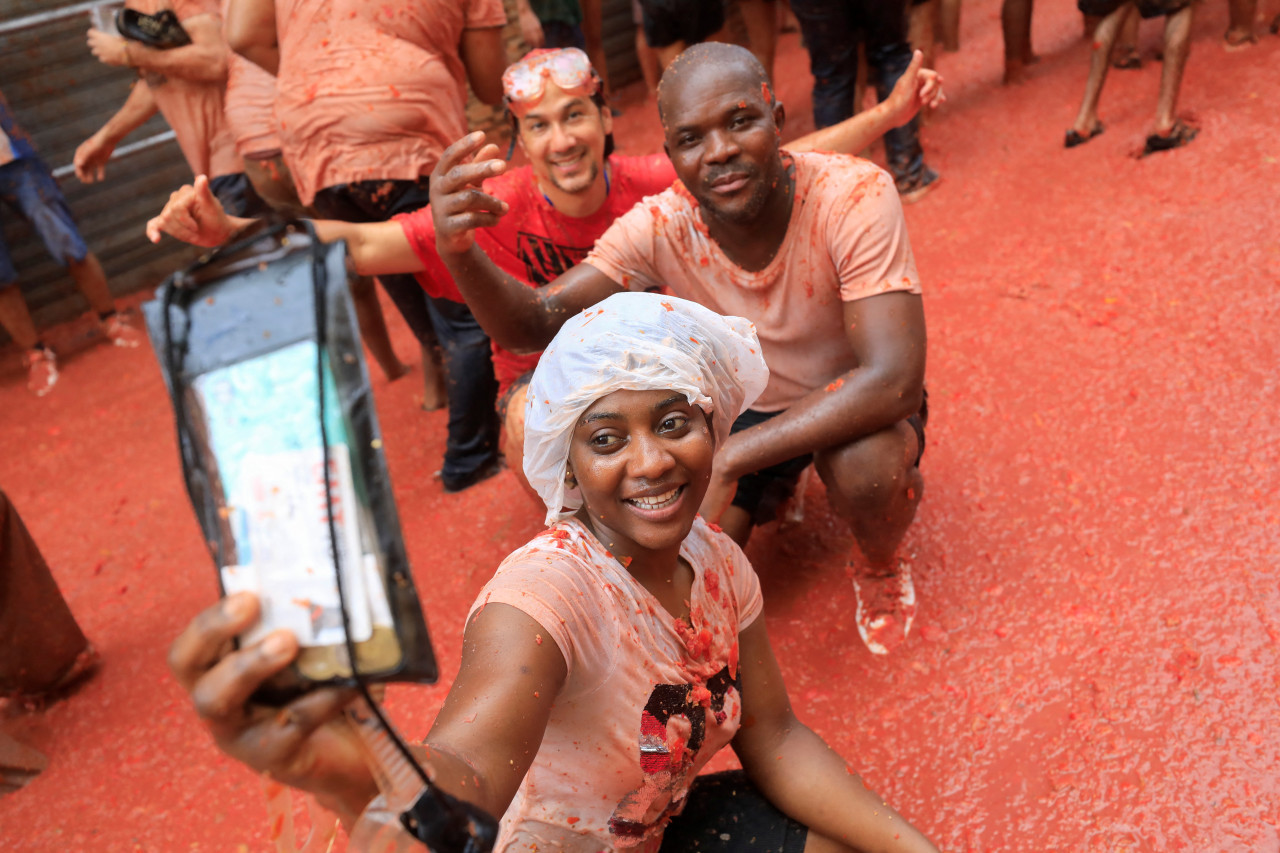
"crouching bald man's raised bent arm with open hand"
431,133,622,352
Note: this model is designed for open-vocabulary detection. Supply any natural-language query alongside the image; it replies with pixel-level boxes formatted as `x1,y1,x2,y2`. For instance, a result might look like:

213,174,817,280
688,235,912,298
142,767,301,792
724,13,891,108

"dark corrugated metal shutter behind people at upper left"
0,0,196,334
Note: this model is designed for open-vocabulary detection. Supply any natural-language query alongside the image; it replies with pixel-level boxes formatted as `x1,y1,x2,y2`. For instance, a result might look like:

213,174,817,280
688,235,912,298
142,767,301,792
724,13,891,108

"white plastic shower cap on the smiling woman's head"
525,293,769,524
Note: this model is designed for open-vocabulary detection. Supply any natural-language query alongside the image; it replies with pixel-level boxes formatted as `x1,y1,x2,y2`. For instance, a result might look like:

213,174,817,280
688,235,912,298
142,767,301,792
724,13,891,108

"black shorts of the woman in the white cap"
659,770,809,853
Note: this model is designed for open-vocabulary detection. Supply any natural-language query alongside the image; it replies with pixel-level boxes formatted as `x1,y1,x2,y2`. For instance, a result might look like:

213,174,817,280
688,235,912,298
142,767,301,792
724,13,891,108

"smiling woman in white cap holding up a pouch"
170,293,937,853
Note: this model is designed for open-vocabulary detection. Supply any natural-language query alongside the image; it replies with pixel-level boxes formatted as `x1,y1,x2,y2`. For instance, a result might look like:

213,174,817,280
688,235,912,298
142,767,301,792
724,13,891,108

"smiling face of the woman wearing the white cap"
568,391,716,558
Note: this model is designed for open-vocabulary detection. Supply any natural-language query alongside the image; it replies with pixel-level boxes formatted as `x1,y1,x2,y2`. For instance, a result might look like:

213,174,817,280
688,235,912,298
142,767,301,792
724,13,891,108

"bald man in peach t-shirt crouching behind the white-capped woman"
431,42,927,654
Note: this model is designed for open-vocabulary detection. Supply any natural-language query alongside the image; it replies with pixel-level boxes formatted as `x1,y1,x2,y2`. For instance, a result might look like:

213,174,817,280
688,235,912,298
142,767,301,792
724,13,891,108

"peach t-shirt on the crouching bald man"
586,152,920,411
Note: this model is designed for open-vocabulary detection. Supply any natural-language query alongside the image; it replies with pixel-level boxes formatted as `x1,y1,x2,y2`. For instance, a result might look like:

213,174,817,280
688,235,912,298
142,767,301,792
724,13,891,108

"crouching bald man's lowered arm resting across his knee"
716,291,925,480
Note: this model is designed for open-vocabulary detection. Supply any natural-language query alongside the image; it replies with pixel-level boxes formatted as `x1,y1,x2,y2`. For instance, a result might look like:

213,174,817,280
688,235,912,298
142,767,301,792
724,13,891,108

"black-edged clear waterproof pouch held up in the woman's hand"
143,225,436,701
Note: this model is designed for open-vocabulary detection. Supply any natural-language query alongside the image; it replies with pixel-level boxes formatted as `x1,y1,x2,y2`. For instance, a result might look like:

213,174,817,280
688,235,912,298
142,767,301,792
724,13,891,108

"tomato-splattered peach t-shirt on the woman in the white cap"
467,516,764,853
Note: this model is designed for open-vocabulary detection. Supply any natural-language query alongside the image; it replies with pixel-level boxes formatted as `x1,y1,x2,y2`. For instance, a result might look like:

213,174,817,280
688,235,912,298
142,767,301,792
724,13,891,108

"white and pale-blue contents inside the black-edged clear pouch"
189,341,402,681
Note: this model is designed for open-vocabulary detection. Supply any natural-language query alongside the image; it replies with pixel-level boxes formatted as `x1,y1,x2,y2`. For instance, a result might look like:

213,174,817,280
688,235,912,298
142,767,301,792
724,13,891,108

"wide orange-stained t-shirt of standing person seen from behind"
275,0,507,204
